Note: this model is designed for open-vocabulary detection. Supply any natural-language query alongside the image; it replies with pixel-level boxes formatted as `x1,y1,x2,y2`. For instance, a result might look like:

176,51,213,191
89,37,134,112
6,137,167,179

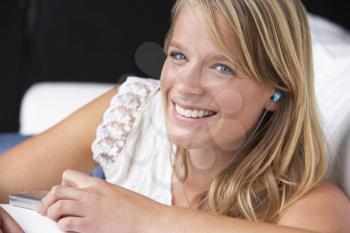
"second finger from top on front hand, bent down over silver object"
37,185,84,215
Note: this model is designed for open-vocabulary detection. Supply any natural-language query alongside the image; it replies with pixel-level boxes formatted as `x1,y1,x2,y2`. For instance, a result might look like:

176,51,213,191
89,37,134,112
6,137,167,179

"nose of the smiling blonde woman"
176,62,204,96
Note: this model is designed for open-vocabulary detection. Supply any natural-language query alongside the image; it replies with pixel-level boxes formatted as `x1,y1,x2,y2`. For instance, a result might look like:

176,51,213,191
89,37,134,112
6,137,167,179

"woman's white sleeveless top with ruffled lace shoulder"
92,77,172,205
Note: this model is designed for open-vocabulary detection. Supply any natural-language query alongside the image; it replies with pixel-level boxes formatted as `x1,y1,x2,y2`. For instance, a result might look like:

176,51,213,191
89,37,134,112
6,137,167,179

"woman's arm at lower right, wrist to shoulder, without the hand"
156,182,350,233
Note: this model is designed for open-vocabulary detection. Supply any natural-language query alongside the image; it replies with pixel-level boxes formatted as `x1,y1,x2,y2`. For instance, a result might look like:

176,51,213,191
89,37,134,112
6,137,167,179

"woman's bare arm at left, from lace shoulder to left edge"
0,85,117,203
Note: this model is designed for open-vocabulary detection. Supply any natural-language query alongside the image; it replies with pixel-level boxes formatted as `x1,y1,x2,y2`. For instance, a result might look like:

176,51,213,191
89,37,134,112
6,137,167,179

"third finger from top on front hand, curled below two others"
47,200,84,222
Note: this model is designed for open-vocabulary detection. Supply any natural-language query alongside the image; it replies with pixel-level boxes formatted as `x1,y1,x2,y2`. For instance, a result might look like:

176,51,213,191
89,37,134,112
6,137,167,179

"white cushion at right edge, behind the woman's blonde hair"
309,15,350,194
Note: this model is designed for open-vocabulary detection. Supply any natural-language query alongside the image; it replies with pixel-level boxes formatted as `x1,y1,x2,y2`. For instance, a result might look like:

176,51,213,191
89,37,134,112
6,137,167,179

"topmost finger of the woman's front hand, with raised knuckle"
62,170,98,188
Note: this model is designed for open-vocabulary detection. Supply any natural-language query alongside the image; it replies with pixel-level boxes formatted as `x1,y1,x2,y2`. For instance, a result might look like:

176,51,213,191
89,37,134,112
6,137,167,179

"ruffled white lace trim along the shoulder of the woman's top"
92,77,159,166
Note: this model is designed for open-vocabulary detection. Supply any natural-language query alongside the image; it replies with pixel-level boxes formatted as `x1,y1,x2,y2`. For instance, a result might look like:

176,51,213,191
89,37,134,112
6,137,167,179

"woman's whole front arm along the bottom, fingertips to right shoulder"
34,170,350,233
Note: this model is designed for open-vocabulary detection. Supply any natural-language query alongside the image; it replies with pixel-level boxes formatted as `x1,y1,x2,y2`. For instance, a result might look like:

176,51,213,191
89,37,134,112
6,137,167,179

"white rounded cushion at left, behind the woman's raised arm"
20,82,114,135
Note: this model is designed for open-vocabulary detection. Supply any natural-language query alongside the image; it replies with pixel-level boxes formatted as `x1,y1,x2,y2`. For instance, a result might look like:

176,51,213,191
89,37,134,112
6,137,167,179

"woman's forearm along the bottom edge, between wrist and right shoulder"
153,207,318,233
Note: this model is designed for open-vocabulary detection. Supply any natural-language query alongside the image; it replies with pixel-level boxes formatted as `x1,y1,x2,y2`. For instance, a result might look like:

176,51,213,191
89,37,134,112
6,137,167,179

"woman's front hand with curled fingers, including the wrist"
38,170,166,233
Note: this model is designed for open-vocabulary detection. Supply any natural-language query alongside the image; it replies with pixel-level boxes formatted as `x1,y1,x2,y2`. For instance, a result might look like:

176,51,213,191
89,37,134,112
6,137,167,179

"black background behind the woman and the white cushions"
0,0,350,132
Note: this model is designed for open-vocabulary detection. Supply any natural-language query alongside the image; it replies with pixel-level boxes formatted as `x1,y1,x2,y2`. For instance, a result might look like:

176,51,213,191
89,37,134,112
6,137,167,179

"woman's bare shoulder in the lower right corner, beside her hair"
278,181,350,233
